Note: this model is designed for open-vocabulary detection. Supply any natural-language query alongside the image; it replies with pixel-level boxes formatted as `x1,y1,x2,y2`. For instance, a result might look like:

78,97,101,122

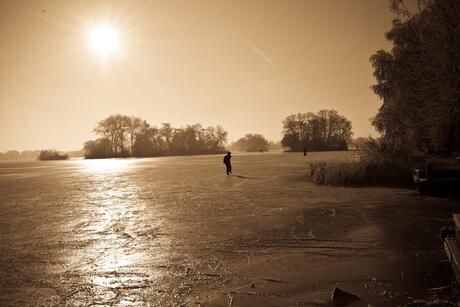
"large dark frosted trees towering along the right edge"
370,0,460,152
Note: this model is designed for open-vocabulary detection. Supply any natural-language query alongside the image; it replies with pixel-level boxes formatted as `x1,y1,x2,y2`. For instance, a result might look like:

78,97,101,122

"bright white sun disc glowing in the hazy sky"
89,24,120,57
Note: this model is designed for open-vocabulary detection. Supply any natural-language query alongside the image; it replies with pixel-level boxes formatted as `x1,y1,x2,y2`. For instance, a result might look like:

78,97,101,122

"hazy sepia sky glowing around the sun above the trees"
0,0,393,151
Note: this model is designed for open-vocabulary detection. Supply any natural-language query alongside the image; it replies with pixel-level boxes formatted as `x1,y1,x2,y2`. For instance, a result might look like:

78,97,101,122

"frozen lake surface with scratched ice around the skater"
0,152,460,306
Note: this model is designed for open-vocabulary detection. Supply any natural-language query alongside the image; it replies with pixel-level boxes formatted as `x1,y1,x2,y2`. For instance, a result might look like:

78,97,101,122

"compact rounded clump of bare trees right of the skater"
281,110,353,151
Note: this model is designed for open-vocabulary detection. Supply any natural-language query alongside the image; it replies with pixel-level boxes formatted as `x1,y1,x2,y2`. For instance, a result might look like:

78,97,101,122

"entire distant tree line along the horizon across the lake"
0,110,352,160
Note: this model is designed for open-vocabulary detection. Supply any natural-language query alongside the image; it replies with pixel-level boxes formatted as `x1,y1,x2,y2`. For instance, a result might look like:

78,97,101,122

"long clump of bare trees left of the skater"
84,114,227,158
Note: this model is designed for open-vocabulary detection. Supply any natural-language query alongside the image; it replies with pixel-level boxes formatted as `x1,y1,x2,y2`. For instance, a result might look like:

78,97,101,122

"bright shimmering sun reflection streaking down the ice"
68,159,170,305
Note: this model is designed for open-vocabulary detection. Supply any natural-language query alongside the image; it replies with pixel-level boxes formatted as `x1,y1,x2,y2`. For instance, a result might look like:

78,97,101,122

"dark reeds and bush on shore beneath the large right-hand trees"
310,139,415,187
